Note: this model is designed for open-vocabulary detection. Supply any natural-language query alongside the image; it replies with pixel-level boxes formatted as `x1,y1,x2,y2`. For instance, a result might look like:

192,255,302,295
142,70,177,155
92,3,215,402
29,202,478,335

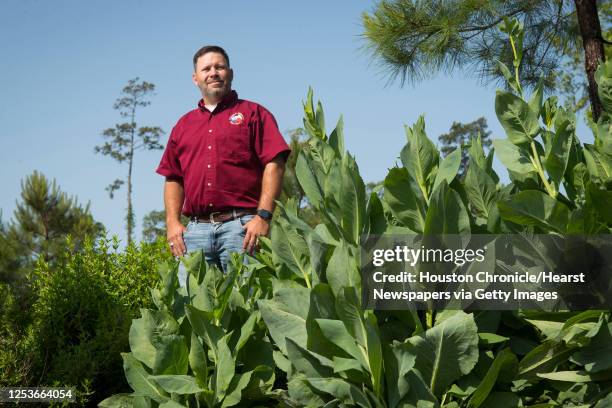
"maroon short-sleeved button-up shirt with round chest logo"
157,91,290,216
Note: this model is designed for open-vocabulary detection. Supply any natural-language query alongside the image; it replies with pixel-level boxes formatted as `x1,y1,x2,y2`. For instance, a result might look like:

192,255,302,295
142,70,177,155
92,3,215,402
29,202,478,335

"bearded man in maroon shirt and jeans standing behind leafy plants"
157,46,289,284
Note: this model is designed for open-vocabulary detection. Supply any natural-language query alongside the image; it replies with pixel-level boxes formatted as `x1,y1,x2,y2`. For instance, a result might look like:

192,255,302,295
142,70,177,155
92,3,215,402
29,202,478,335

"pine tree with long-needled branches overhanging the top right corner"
362,0,610,120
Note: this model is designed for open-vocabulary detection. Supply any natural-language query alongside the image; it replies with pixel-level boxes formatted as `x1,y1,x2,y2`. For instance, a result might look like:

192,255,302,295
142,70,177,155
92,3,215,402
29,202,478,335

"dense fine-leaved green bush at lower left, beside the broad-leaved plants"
0,234,170,403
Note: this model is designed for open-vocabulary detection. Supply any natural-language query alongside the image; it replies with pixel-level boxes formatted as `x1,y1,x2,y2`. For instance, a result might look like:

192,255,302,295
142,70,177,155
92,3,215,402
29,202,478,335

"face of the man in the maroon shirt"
193,52,234,103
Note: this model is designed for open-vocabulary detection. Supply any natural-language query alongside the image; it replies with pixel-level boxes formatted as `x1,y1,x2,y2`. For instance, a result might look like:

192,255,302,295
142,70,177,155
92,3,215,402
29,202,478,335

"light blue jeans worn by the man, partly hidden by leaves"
178,214,254,287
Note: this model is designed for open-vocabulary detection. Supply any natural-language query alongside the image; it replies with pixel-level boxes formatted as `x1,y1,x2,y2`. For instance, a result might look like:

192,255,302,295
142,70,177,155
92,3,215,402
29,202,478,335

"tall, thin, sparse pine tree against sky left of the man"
94,78,164,244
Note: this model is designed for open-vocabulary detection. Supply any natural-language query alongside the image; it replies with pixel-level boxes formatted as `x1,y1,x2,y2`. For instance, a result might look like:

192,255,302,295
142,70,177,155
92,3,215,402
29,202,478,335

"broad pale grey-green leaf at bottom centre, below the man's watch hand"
257,288,310,355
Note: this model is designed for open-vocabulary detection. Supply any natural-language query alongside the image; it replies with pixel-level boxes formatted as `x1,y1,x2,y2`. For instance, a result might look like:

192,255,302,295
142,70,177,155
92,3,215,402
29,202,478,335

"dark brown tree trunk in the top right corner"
574,0,605,122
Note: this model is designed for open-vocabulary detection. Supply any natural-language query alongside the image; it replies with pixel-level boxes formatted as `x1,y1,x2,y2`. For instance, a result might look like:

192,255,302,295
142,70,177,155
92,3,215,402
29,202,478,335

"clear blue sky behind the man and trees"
0,0,592,239
